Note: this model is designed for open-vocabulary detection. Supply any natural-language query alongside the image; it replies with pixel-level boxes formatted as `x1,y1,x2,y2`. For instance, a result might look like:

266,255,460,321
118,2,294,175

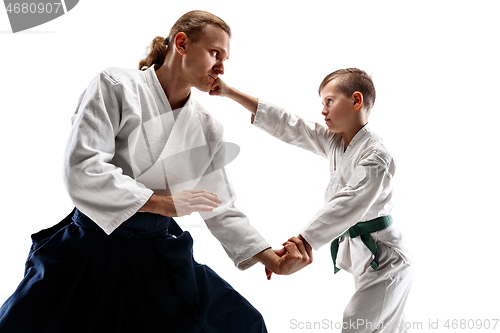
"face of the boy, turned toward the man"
321,79,355,133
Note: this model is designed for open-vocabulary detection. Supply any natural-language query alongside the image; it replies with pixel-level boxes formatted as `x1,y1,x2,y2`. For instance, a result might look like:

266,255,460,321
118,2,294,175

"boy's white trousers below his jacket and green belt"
342,242,413,333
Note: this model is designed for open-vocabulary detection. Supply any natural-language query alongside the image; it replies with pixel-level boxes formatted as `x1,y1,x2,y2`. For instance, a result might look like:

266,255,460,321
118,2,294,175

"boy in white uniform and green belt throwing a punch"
210,68,412,333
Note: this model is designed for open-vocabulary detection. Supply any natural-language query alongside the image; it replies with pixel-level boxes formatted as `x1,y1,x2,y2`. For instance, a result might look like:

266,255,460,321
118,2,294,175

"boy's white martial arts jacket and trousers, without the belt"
253,100,412,333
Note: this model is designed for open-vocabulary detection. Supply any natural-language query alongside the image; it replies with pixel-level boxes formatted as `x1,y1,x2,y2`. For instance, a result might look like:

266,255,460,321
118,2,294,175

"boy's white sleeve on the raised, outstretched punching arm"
252,100,334,157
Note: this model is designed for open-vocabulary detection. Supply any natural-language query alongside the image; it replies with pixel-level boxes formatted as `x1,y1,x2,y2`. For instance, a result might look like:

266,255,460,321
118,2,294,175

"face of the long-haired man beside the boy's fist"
182,25,230,92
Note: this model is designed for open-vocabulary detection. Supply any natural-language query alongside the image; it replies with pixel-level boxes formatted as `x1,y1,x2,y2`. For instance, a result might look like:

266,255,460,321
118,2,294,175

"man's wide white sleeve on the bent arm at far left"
64,72,153,234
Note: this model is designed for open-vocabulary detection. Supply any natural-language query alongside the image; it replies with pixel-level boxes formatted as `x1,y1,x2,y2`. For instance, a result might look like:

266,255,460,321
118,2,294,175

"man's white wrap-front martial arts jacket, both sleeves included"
64,66,270,269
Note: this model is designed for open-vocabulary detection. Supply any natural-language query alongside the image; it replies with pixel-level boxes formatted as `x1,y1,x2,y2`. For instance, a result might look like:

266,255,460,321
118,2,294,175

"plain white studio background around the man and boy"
0,0,500,333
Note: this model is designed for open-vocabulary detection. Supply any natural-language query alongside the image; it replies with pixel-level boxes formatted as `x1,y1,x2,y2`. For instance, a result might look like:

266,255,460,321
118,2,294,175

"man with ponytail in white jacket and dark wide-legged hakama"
0,11,312,333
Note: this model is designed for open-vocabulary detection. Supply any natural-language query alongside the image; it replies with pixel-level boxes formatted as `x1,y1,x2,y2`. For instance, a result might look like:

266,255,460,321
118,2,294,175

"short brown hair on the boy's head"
318,68,376,110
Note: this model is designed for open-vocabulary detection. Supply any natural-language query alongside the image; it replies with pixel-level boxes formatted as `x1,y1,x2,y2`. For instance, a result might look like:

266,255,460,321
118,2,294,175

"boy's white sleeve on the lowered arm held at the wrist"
300,159,392,250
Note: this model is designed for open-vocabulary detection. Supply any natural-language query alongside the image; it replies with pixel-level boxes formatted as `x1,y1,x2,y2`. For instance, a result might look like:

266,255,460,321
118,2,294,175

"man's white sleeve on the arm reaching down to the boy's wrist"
197,139,271,270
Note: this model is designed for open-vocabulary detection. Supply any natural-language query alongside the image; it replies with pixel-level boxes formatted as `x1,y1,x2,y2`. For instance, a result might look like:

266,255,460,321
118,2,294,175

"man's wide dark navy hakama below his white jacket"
0,210,267,333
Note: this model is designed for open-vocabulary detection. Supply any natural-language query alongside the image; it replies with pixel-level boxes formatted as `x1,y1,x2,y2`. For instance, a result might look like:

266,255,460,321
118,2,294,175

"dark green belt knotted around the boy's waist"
330,215,392,273
